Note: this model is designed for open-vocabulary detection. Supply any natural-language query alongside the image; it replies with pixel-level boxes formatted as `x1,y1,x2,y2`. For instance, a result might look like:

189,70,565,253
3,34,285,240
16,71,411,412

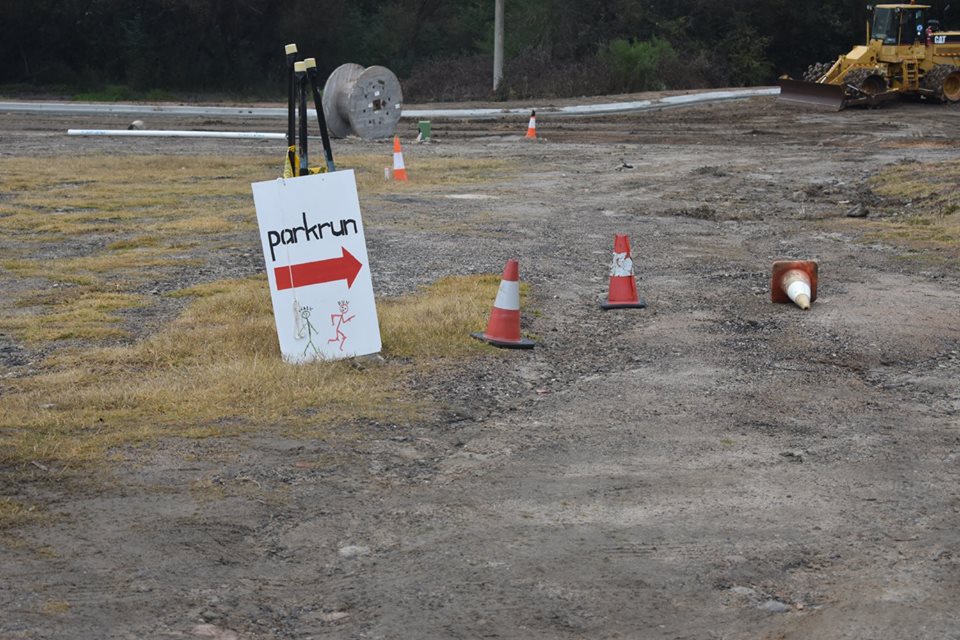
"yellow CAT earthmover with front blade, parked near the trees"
780,4,960,111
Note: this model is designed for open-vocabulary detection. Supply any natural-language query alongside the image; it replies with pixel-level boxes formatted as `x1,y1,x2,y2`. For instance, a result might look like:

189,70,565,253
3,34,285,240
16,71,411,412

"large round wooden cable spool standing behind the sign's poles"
323,63,403,140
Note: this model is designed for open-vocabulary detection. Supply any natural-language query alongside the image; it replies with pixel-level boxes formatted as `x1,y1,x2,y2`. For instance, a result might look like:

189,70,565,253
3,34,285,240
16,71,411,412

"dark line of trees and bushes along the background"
0,0,960,101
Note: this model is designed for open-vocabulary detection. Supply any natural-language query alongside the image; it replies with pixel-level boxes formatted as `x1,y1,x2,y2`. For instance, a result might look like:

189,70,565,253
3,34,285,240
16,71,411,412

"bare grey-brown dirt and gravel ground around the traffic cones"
0,98,960,640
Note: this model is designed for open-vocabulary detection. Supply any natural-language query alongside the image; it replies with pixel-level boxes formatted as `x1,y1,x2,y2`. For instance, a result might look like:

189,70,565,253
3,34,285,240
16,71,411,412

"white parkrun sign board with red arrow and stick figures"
252,171,381,362
